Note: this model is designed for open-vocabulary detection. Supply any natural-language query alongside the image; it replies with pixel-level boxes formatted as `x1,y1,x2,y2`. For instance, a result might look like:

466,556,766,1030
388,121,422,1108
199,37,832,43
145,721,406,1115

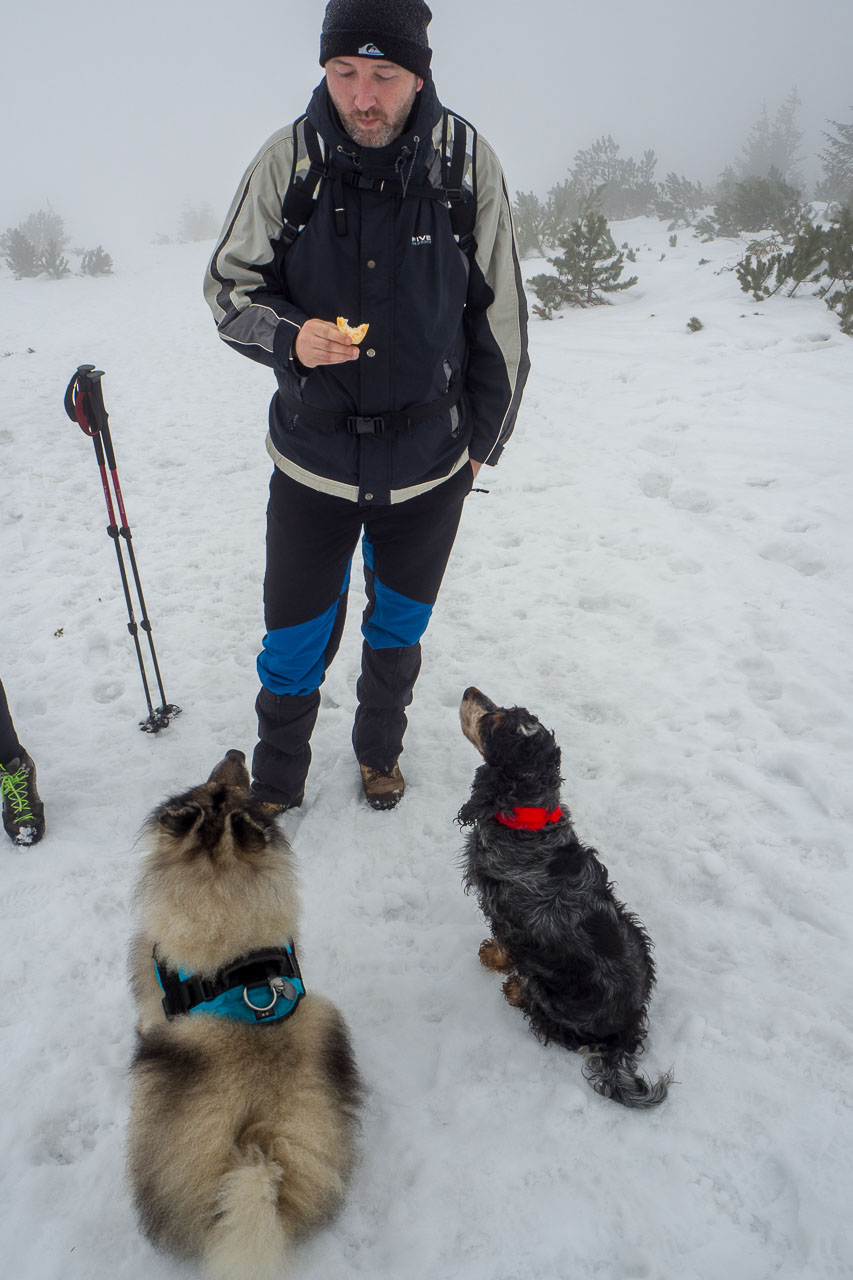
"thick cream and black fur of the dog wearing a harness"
128,751,361,1280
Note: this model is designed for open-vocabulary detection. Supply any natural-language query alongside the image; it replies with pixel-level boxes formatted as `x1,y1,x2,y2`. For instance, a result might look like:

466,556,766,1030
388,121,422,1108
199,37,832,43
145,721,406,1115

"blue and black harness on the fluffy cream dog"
154,942,305,1024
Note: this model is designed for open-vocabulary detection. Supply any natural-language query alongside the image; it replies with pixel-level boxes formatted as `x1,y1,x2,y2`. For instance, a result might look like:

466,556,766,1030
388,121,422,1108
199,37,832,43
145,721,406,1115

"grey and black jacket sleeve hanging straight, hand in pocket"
465,137,530,466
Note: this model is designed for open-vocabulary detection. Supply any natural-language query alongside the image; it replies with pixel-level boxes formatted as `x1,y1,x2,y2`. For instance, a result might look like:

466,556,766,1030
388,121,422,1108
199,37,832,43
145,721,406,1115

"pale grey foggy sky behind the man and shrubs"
0,0,853,251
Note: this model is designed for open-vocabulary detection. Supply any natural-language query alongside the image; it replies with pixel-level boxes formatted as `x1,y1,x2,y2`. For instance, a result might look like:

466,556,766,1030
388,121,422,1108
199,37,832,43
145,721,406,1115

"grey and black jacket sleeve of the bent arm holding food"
205,127,309,367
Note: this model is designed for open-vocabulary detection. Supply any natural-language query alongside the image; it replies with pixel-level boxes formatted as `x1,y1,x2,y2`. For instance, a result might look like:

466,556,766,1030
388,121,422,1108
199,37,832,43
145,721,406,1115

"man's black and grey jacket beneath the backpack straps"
205,79,529,504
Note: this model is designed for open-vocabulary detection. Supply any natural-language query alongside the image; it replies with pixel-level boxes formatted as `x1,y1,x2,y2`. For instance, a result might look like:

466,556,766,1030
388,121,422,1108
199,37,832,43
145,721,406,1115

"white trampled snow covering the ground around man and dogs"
0,220,853,1280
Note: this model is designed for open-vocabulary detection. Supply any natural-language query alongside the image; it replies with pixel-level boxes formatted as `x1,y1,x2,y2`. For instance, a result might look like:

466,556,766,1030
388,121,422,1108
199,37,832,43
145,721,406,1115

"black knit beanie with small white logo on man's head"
320,0,433,79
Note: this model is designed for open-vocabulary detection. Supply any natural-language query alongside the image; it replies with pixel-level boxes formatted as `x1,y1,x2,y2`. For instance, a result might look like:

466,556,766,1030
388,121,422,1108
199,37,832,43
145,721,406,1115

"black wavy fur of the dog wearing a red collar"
459,689,671,1107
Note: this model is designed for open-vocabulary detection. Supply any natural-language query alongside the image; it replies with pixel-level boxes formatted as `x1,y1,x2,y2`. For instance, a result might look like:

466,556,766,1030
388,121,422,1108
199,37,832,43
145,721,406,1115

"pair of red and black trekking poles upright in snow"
65,365,181,733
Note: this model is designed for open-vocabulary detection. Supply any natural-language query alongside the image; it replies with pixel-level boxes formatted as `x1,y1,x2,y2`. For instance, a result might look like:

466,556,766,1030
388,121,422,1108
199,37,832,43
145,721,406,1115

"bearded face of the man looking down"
325,58,424,147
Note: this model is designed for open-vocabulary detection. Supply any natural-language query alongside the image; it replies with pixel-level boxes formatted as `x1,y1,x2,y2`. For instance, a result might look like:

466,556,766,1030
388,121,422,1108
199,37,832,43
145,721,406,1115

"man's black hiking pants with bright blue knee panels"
252,463,473,804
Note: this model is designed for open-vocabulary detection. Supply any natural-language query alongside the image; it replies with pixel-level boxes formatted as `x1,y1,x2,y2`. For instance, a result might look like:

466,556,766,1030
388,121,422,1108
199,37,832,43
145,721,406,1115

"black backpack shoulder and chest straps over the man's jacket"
282,108,476,255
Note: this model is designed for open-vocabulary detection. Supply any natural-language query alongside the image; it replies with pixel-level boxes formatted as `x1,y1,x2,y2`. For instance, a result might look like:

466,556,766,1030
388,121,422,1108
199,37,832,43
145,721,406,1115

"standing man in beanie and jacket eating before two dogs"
205,0,529,812
